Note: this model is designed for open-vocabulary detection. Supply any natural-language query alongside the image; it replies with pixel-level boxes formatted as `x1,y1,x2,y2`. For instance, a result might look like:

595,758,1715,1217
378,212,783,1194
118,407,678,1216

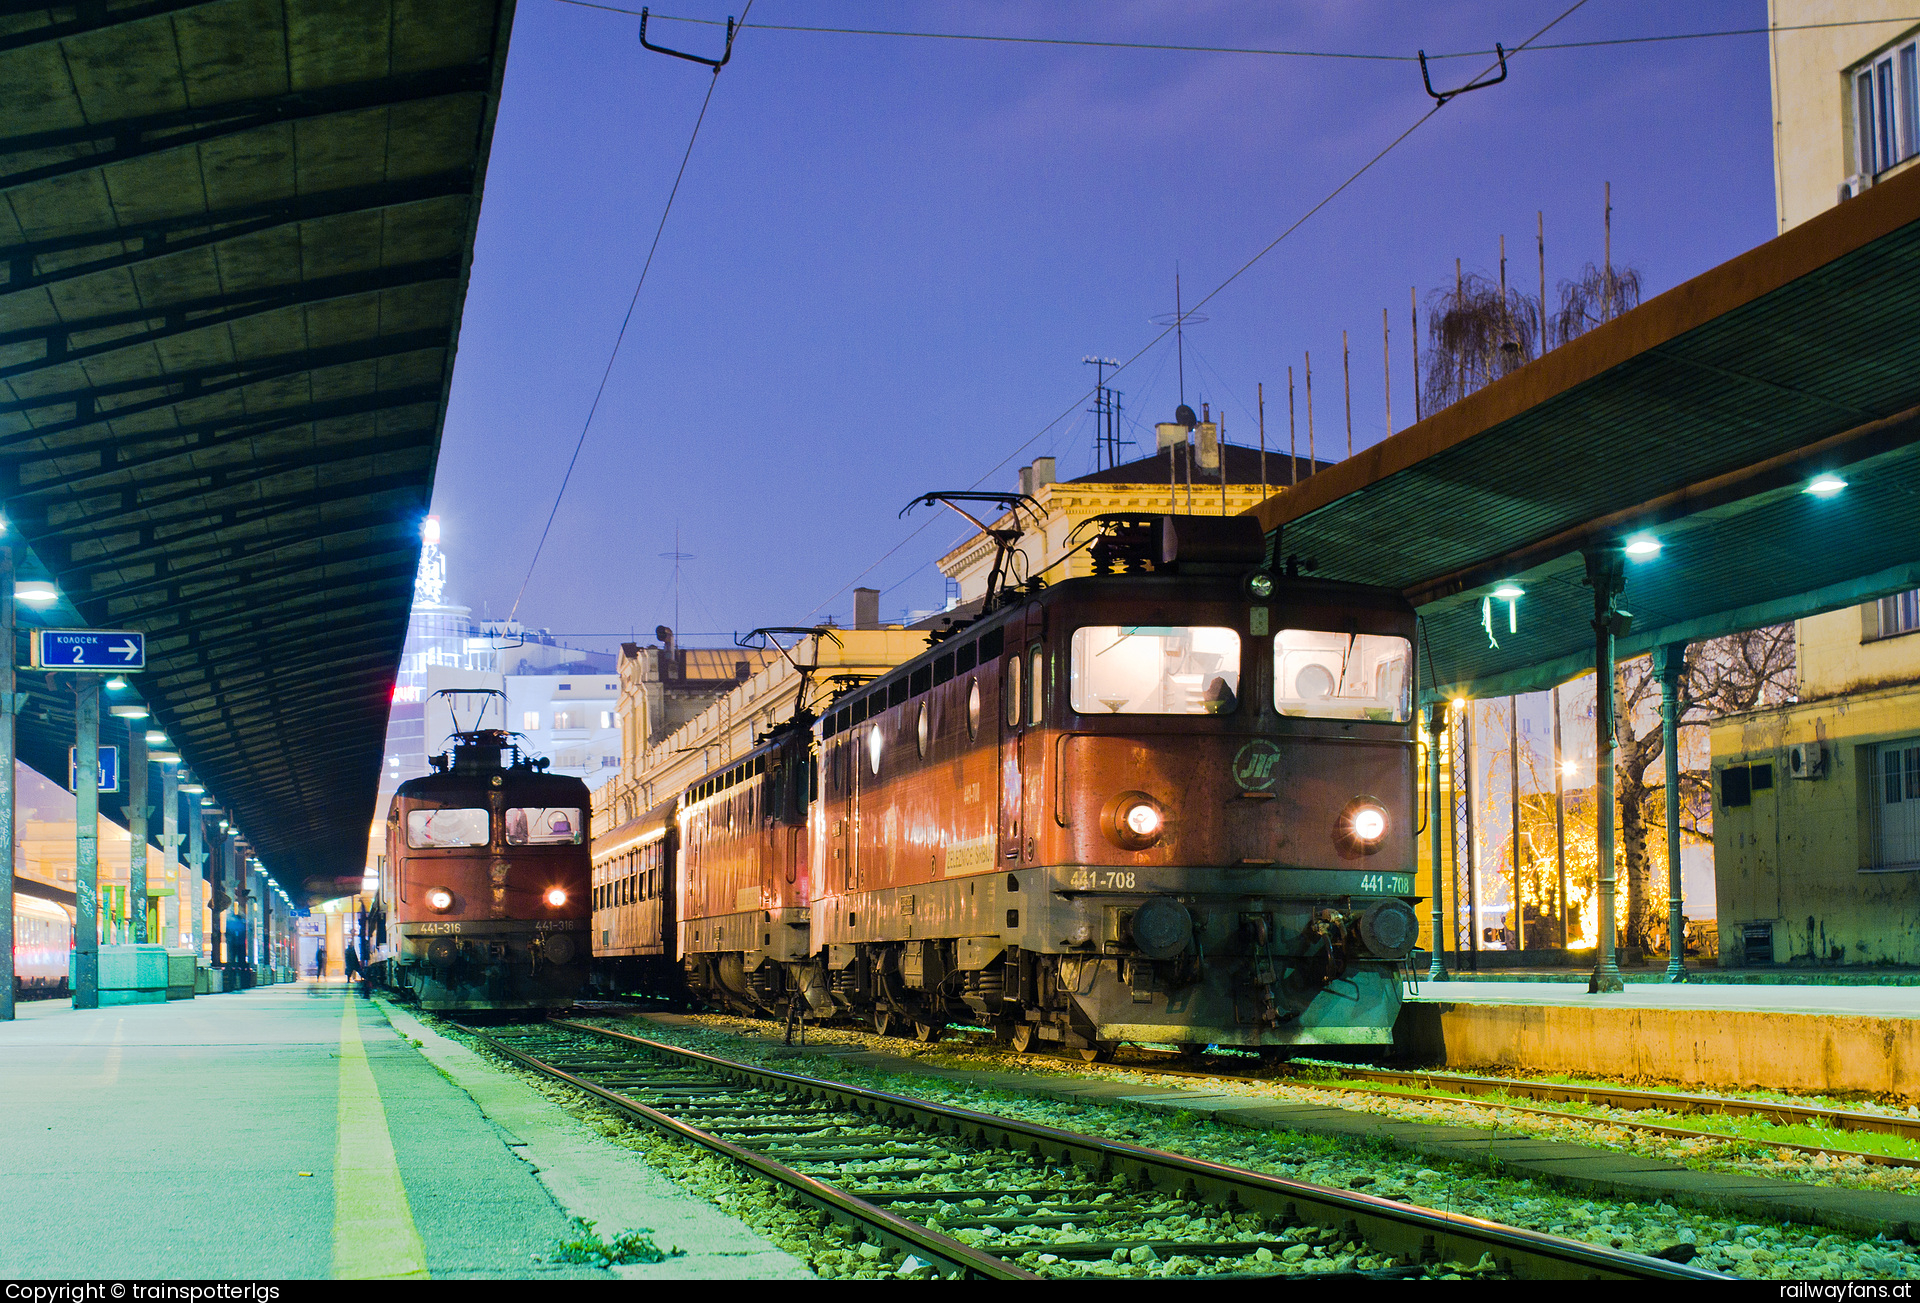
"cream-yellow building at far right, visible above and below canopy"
1711,0,1920,965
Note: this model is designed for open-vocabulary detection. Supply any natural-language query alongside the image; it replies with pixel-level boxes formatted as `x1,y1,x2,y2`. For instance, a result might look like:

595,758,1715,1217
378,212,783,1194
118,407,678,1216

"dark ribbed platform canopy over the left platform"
0,0,513,890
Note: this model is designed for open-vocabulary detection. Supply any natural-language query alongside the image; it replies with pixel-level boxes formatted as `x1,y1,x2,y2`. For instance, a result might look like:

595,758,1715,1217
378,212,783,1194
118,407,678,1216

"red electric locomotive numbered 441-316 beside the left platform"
369,710,591,1009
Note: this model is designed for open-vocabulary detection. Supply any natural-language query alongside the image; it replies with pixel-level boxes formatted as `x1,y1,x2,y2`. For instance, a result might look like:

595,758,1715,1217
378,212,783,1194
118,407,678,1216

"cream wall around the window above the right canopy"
1766,0,1920,230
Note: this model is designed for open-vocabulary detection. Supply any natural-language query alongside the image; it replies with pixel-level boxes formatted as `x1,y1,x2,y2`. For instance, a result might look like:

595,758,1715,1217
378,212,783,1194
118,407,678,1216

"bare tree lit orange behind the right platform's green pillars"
1613,624,1795,946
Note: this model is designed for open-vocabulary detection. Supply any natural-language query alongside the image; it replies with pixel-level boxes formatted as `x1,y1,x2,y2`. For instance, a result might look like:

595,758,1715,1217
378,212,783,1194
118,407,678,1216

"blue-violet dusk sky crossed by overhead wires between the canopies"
434,0,1774,647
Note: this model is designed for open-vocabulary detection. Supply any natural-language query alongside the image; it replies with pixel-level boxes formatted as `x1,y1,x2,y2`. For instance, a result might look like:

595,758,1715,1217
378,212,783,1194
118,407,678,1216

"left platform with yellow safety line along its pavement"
0,981,808,1280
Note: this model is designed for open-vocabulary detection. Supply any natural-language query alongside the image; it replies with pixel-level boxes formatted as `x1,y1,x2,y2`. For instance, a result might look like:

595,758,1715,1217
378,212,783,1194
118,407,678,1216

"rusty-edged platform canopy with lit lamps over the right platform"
1256,171,1920,700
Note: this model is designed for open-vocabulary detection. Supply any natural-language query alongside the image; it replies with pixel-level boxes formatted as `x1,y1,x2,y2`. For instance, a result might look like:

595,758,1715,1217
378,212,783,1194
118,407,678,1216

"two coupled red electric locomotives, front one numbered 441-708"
660,514,1417,1059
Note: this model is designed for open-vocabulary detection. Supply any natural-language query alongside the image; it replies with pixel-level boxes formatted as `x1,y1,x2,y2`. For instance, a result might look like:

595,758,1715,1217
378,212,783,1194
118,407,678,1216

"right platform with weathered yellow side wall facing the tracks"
1394,975,1920,1100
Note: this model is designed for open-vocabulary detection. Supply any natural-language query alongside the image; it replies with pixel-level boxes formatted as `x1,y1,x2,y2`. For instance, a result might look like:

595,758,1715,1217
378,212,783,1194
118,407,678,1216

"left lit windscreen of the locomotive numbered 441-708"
1068,624,1240,716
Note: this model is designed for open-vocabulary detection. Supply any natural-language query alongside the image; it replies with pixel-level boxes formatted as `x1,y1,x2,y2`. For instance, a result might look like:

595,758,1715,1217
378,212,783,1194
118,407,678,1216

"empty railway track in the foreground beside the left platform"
463,1019,1718,1280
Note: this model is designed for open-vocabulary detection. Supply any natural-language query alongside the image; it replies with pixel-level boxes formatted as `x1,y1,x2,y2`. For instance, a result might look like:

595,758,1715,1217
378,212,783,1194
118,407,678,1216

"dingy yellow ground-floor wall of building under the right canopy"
1713,683,1920,965
